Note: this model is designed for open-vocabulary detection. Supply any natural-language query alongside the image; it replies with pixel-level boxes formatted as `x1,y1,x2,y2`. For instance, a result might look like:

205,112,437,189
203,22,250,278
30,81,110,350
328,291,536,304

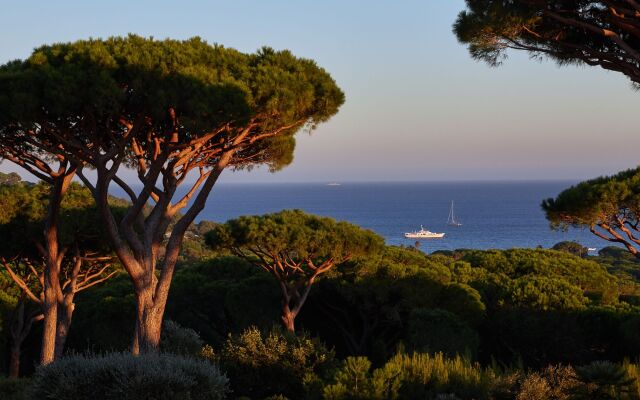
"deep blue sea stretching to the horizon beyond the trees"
199,181,608,252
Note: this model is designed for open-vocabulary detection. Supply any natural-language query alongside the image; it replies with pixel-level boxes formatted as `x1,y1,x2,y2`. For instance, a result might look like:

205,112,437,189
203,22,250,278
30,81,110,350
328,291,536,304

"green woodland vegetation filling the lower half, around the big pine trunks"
0,170,640,399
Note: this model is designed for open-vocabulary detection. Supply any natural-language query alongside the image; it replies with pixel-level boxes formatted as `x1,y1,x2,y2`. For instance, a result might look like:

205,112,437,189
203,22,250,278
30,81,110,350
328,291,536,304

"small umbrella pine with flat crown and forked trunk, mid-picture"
207,210,384,332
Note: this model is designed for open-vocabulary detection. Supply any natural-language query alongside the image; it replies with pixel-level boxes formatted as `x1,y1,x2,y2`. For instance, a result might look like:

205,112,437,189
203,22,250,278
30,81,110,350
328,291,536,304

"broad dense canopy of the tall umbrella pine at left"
0,35,344,173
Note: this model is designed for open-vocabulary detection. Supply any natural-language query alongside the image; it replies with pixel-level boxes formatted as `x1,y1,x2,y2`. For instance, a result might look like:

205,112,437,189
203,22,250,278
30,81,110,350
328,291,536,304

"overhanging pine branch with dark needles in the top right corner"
454,0,640,84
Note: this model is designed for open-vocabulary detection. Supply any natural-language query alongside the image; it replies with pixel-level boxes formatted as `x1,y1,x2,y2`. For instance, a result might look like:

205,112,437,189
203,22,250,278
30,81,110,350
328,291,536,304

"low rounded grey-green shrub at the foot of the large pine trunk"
29,353,228,400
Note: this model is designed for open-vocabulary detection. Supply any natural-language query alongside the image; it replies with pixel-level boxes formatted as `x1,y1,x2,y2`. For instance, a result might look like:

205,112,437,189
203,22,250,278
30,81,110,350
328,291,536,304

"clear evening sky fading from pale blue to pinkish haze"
0,0,640,183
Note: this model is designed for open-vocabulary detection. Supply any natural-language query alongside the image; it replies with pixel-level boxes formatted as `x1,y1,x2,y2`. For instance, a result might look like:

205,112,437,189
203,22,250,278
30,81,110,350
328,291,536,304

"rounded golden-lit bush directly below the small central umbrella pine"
217,328,334,399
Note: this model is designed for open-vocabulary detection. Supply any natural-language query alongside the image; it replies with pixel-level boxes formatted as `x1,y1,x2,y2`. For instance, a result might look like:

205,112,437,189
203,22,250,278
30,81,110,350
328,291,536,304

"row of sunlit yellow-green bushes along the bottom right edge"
323,353,640,400
